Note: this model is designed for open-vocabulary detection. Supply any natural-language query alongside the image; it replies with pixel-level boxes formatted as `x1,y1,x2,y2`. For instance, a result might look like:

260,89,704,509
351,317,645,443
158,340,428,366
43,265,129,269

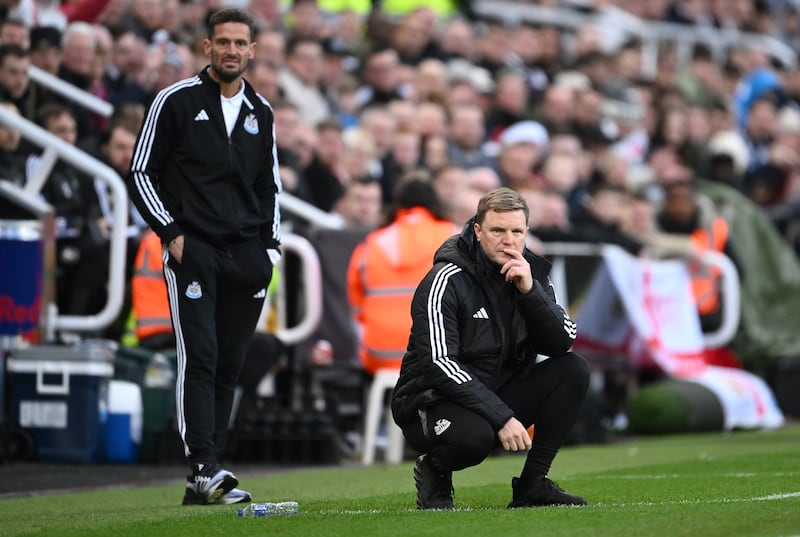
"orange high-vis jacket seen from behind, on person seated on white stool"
347,207,458,375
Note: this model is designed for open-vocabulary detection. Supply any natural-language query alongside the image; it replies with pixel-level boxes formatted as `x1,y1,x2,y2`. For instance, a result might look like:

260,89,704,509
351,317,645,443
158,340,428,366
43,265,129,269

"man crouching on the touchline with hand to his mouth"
392,188,589,509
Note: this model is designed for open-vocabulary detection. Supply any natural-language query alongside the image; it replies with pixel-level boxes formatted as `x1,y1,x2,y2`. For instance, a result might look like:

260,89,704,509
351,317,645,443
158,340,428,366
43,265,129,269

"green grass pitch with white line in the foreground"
0,424,800,537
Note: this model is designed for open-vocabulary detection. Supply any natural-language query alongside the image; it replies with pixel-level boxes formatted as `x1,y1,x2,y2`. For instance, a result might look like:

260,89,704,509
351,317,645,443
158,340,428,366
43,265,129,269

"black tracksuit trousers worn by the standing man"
164,235,272,463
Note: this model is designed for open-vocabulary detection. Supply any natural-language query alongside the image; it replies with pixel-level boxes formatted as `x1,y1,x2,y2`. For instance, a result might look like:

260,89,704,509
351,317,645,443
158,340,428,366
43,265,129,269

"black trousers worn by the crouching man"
403,352,589,480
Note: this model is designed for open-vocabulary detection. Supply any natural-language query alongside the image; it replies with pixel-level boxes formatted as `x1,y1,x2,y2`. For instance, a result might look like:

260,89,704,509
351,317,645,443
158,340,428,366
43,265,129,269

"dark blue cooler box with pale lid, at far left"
6,340,115,463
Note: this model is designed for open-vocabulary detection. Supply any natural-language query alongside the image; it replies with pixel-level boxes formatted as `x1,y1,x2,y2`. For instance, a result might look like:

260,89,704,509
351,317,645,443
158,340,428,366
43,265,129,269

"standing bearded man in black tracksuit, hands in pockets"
128,9,281,504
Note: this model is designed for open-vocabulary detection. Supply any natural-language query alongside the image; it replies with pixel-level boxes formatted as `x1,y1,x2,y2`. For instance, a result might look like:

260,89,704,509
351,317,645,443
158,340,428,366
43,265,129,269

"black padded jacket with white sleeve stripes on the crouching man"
392,218,576,431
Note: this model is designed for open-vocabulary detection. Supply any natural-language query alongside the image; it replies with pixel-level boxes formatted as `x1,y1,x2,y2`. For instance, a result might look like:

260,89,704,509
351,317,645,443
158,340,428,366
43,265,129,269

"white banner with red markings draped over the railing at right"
575,246,784,429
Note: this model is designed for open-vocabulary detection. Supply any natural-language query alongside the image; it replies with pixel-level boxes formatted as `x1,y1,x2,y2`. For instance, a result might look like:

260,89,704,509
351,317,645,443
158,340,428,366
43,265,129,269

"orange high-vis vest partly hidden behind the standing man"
131,230,172,339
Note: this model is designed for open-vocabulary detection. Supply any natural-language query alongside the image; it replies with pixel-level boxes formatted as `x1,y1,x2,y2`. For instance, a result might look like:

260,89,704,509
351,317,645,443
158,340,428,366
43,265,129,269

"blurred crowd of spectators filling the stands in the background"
0,0,800,344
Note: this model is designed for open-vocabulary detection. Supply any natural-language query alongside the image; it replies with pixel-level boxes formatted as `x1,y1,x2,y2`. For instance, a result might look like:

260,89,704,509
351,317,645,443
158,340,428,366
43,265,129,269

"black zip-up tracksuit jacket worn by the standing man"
128,68,281,249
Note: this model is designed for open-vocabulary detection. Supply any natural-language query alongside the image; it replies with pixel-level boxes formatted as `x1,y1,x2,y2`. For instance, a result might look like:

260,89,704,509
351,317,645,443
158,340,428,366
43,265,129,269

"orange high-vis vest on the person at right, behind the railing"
690,217,728,315
